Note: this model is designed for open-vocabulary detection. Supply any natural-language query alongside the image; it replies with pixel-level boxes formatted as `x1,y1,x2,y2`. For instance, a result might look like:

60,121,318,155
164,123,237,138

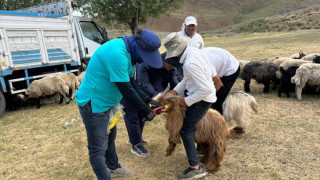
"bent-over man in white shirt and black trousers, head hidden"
201,47,240,114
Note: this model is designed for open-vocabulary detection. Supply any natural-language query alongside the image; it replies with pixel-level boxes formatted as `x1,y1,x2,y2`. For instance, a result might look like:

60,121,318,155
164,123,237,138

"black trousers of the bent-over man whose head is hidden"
211,66,240,114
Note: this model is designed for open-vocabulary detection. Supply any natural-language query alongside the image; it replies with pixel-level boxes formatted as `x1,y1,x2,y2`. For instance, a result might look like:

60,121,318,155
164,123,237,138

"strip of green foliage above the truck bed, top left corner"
0,0,59,10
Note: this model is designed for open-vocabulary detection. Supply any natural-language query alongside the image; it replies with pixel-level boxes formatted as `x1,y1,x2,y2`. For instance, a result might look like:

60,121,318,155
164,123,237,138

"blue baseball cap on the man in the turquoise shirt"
136,29,163,69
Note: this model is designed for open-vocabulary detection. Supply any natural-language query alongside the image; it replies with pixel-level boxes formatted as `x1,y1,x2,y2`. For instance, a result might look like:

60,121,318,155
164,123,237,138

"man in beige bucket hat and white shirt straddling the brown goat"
164,33,217,179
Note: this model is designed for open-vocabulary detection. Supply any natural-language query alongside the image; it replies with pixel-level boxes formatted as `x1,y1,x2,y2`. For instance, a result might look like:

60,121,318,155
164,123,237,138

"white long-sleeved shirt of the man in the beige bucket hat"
174,46,217,106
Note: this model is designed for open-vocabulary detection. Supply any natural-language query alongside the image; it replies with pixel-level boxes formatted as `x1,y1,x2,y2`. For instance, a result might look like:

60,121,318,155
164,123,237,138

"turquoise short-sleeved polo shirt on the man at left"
75,39,134,113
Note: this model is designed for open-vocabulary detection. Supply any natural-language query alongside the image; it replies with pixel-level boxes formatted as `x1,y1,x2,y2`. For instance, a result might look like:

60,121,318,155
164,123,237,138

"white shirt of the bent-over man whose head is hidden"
201,47,239,78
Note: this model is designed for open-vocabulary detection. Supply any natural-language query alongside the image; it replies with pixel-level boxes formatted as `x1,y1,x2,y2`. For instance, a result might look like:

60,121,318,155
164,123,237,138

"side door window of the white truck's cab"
80,21,103,44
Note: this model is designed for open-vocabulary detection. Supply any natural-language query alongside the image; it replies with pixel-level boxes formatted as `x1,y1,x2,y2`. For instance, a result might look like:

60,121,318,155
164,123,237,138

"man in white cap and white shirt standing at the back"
178,16,204,49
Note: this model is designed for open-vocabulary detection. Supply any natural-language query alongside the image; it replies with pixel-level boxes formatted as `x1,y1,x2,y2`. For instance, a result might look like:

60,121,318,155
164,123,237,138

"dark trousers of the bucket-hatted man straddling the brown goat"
180,101,212,166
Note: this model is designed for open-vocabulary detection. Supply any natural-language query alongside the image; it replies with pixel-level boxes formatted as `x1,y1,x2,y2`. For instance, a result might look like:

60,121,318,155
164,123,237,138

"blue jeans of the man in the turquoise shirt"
78,101,120,180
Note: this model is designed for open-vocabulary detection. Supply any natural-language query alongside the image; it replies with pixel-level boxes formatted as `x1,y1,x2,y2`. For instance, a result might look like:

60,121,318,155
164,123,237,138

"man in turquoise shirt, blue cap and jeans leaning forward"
76,30,162,180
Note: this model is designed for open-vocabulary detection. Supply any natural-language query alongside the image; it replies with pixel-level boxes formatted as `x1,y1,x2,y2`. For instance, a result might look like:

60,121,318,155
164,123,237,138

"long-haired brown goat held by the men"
154,94,242,173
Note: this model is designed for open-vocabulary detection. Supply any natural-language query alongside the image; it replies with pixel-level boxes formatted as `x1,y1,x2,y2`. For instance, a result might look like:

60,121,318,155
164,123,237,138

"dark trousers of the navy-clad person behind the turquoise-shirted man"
120,98,144,145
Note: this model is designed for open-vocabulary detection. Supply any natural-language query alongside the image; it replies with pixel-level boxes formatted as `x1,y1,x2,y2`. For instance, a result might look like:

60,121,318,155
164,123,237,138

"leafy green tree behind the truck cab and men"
76,0,184,32
